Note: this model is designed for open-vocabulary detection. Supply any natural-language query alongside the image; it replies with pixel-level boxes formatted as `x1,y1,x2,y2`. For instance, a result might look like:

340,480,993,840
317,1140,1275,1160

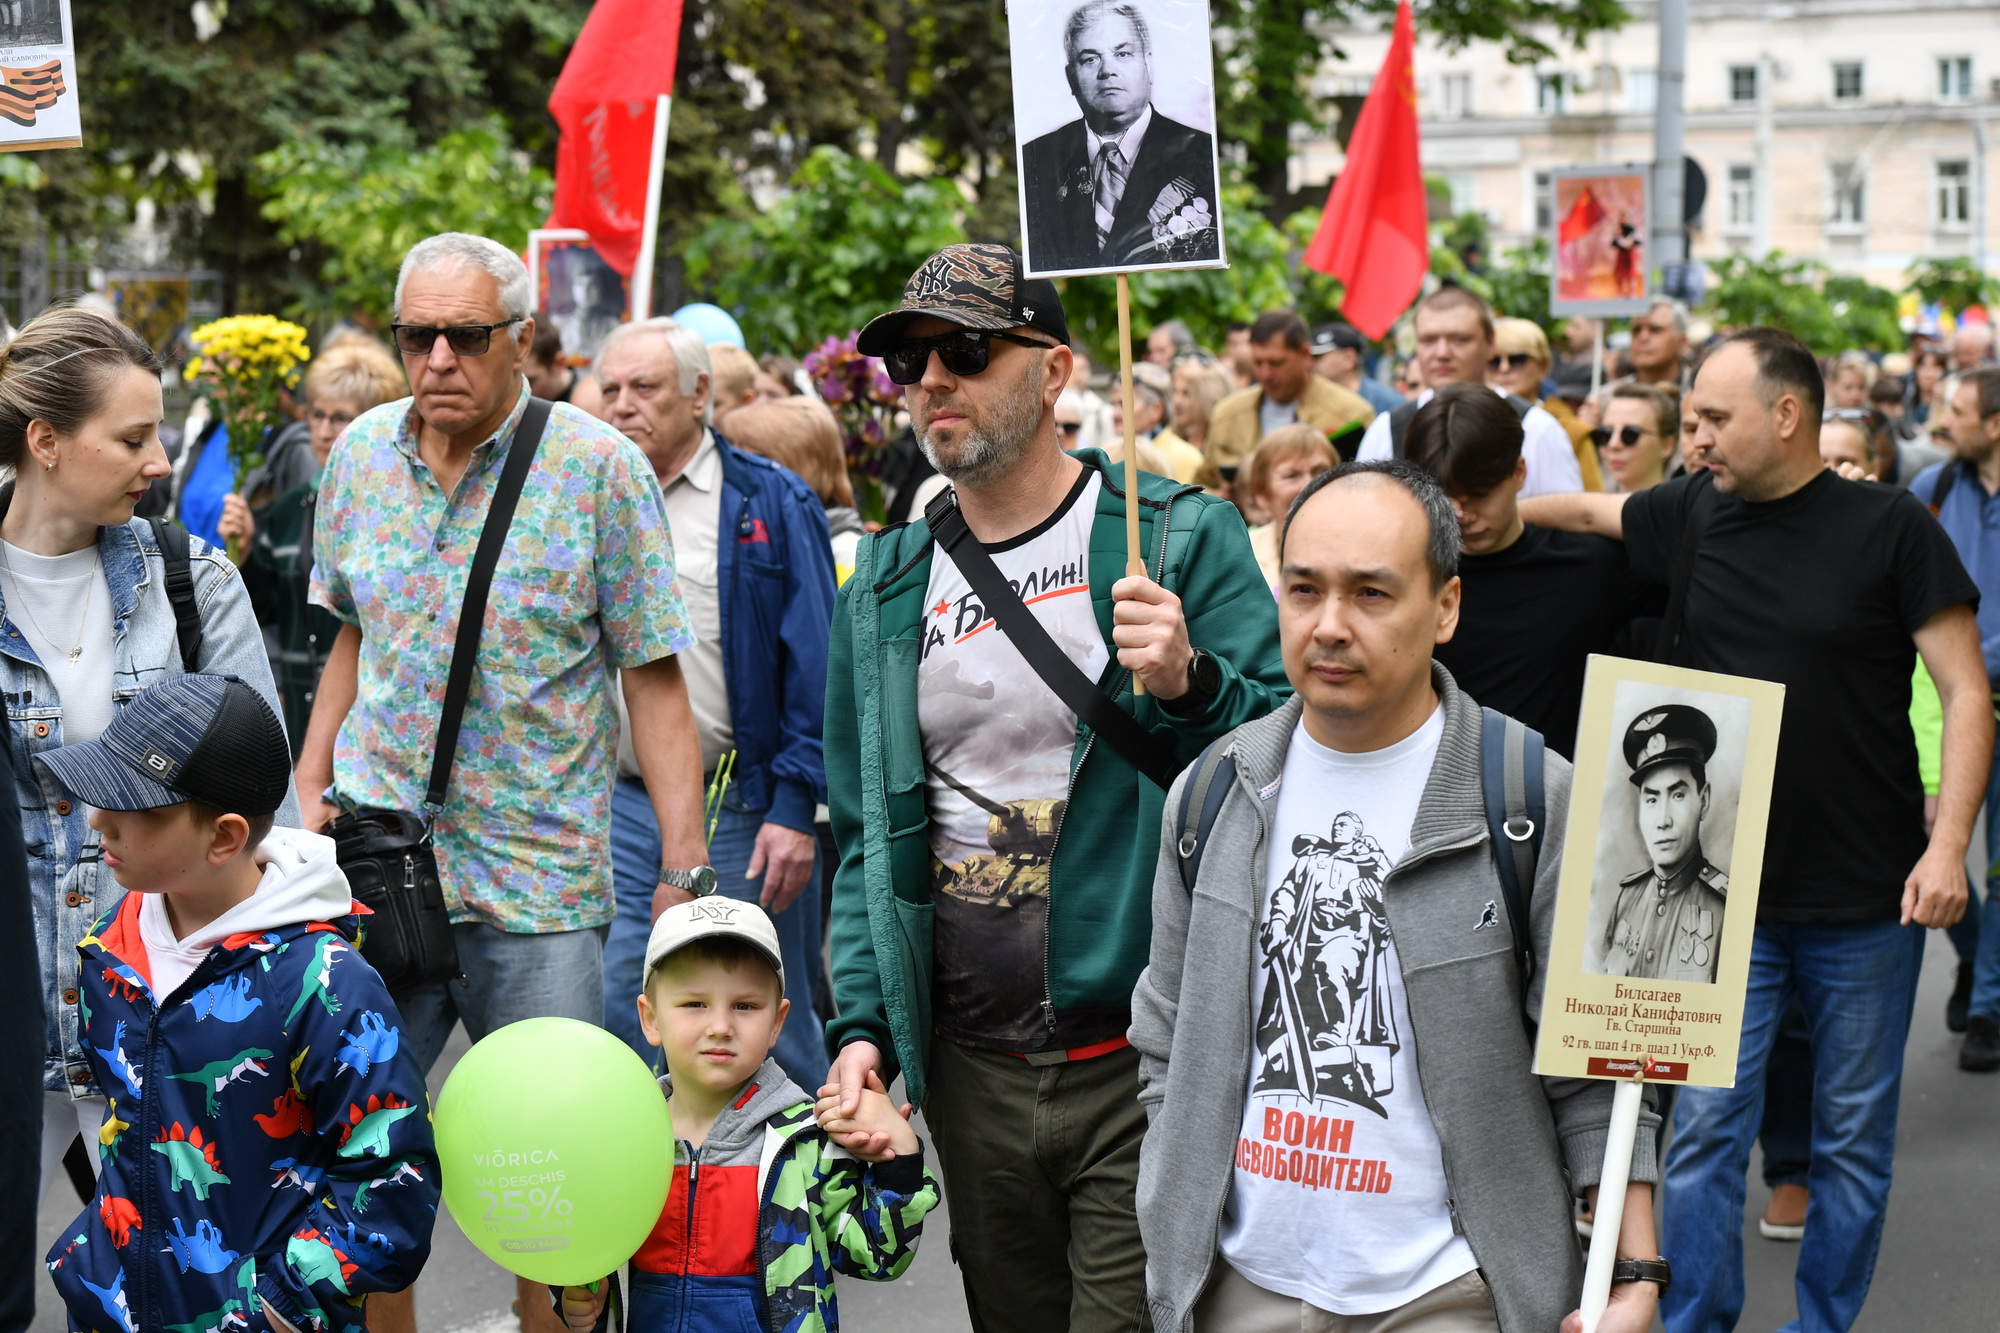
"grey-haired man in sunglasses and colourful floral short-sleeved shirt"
298,232,708,1329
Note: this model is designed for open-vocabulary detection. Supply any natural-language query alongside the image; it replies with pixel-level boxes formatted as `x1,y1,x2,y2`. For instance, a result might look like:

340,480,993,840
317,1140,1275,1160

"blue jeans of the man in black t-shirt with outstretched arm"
1660,921,1924,1333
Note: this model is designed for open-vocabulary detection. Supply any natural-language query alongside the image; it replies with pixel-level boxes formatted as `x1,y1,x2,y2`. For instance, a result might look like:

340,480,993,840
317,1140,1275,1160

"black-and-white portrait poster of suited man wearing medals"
1006,0,1228,276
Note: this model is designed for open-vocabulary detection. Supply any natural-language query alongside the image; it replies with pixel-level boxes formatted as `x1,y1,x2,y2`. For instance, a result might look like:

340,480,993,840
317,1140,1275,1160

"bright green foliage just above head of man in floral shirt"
256,118,554,324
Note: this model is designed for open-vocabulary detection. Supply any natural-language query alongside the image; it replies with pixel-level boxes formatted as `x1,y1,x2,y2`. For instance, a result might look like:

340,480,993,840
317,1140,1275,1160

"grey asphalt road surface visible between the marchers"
34,935,2000,1333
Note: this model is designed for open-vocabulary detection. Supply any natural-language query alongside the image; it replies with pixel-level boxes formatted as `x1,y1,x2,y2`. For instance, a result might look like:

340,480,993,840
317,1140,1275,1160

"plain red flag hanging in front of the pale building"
1306,0,1430,338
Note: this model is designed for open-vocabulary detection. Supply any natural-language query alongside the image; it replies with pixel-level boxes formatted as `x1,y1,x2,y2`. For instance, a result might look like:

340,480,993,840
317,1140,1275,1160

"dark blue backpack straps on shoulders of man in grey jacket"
1174,709,1548,1043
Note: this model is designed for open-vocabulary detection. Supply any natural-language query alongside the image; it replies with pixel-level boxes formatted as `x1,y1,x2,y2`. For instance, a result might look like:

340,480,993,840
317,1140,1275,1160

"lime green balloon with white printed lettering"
432,1019,674,1287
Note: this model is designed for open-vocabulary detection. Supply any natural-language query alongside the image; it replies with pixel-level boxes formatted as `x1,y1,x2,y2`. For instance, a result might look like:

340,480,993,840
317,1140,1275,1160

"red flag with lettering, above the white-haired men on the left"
548,0,682,276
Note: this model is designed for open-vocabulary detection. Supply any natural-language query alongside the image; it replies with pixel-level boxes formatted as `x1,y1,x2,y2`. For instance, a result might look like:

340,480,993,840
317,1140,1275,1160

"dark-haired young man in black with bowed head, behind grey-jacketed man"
1404,384,1642,759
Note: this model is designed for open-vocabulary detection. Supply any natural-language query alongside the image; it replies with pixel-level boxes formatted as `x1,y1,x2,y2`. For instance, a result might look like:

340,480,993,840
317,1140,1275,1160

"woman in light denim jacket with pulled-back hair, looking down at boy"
0,308,298,1193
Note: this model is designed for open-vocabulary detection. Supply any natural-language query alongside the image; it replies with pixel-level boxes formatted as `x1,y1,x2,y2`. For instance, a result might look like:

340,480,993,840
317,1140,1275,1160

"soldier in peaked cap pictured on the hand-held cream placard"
1600,705,1730,983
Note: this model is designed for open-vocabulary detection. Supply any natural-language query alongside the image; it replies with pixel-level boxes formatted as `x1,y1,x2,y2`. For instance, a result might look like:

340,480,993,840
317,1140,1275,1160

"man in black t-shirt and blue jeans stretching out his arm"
1522,328,1994,1333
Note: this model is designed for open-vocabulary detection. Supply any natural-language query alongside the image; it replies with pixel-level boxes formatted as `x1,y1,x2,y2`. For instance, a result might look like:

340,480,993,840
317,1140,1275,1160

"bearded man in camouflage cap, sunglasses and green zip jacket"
822,244,1286,1333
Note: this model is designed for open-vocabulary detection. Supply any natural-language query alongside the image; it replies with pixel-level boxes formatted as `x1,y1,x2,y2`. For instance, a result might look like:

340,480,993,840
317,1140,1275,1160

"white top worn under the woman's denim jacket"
0,542,116,745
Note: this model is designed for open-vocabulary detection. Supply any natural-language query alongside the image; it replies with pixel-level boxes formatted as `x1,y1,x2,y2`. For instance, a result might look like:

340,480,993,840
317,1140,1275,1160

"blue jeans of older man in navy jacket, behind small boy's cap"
602,779,828,1093
